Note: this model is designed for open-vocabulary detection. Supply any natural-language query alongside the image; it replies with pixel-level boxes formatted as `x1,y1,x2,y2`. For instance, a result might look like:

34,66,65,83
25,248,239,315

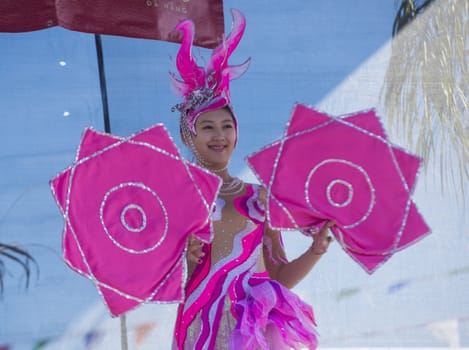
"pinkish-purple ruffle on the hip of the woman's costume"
230,280,318,350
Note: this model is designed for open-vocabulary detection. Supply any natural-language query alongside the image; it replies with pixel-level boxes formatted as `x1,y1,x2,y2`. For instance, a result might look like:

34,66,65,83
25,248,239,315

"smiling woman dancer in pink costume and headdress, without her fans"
171,10,334,350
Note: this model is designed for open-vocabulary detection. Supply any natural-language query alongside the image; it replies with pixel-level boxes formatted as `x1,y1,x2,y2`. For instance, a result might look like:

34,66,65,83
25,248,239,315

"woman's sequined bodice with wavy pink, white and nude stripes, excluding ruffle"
175,184,265,349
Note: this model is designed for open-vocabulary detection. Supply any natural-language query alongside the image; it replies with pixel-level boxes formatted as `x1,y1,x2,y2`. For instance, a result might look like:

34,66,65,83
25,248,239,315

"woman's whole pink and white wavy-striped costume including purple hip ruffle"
173,185,317,350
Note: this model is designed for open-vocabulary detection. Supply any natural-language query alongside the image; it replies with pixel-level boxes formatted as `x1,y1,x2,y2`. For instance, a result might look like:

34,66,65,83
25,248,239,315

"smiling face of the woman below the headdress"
192,108,237,169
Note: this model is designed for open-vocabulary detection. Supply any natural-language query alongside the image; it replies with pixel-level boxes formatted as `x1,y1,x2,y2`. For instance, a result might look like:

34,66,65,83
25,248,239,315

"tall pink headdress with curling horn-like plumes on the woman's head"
170,9,251,135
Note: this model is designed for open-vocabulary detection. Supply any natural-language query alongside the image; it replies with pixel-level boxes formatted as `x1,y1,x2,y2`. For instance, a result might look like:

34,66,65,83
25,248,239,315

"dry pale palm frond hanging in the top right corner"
381,0,469,198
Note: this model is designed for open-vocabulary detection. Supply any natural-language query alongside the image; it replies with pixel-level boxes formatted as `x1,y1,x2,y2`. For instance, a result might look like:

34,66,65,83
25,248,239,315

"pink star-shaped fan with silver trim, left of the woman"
51,125,221,316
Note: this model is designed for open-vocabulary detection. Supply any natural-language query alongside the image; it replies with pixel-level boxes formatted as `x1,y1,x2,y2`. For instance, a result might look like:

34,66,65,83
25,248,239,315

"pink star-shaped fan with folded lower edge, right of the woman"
247,104,429,273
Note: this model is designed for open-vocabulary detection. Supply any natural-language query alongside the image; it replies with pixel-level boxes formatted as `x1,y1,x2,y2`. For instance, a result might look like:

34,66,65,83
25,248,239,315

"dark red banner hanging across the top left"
0,0,224,48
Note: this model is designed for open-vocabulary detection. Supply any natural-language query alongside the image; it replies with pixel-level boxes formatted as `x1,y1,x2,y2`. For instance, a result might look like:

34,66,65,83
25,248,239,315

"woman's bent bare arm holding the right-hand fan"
264,221,335,288
